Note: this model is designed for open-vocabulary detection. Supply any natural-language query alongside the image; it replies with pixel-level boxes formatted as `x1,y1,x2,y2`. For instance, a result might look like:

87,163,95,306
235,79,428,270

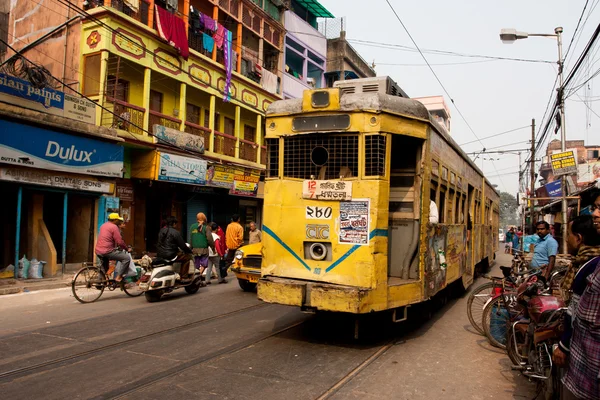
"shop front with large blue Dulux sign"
0,120,123,277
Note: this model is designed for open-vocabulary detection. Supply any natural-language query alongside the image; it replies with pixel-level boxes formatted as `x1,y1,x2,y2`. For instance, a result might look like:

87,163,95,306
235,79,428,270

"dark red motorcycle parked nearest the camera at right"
506,276,567,400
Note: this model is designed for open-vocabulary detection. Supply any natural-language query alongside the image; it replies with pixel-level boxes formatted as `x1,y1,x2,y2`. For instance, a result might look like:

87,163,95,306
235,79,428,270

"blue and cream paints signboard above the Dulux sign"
0,73,96,124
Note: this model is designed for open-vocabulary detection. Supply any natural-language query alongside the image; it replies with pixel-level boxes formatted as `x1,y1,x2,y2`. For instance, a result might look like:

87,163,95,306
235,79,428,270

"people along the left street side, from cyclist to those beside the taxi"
96,213,262,286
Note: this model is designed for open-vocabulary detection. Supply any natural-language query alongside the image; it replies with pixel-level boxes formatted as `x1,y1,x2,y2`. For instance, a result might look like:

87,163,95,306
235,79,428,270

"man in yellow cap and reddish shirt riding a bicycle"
96,213,131,282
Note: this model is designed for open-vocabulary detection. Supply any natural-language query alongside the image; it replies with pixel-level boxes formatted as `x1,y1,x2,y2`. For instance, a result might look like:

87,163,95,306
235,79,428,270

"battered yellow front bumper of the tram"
258,276,372,314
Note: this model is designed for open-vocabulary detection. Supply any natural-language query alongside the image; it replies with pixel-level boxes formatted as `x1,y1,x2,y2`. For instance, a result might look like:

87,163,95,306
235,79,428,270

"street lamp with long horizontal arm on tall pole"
500,26,567,252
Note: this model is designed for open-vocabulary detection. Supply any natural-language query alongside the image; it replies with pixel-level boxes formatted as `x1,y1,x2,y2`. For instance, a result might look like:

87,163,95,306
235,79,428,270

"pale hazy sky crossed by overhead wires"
321,0,600,194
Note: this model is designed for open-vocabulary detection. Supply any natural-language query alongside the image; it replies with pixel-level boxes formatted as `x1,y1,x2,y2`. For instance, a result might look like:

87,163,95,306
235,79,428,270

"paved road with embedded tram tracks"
0,255,535,400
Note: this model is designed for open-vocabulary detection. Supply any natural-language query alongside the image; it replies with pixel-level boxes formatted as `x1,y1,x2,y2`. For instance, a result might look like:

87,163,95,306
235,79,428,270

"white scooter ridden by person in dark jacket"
139,245,202,303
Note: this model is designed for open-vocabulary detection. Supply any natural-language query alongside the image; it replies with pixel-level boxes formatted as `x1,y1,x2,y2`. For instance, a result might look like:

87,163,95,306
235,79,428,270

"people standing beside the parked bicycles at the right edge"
532,191,600,400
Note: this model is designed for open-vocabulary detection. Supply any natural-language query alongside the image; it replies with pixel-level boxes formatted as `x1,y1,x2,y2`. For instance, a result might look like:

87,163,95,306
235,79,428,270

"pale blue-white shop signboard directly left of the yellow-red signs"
158,153,206,185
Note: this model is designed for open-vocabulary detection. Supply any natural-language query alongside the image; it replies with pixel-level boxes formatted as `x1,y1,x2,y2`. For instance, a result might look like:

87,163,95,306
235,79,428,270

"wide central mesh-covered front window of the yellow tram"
283,133,358,179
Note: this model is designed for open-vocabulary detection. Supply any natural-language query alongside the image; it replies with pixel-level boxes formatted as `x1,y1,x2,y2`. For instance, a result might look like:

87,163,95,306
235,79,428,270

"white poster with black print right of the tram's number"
340,199,369,245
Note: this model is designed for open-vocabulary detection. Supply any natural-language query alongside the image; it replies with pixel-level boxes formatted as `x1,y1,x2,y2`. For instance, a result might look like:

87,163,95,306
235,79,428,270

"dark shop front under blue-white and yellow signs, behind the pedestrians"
129,151,262,252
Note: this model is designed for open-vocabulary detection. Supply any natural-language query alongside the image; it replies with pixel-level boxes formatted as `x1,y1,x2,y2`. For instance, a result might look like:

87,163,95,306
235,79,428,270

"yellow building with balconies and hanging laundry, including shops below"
0,0,285,261
